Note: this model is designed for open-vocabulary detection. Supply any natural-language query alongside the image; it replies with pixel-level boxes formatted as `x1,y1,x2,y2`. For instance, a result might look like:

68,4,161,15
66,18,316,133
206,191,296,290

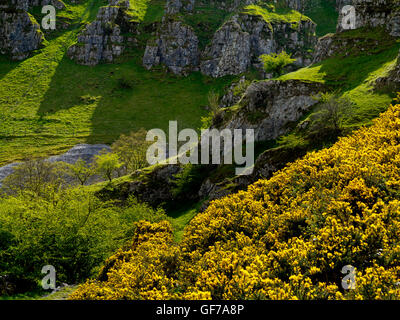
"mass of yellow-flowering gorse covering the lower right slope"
72,97,400,299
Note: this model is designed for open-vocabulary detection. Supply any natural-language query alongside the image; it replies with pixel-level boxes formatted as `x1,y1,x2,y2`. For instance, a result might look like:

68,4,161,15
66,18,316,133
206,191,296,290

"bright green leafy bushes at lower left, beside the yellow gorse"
0,188,168,292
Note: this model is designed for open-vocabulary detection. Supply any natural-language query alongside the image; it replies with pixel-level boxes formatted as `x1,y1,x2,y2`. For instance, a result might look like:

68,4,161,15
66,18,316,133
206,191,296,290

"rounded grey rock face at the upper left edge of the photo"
0,11,44,60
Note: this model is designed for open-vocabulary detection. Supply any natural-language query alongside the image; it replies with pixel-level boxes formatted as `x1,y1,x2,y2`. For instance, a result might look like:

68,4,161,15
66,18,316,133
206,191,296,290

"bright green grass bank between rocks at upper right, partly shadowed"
278,29,400,128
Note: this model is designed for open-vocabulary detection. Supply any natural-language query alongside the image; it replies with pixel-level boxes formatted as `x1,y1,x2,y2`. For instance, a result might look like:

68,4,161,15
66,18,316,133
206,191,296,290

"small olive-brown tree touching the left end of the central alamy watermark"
111,129,150,174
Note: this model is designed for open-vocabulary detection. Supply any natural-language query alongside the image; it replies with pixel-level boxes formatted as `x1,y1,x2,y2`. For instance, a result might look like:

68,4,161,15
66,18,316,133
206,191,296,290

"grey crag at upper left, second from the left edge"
67,0,137,66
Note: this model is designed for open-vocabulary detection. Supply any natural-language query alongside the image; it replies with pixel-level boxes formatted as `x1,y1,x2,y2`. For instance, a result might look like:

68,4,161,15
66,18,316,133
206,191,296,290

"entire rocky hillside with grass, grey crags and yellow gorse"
0,0,400,299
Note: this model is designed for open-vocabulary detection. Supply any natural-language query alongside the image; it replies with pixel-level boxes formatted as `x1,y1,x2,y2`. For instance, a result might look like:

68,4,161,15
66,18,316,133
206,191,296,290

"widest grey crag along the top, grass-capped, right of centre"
200,14,316,77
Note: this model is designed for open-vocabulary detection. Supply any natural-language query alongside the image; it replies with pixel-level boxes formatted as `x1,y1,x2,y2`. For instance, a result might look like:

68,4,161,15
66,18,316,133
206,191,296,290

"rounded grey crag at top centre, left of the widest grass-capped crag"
143,20,199,74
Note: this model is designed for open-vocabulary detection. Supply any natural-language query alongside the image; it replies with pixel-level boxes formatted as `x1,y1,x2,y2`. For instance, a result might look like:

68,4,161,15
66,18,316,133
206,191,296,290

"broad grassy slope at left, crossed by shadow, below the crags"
0,0,233,164
